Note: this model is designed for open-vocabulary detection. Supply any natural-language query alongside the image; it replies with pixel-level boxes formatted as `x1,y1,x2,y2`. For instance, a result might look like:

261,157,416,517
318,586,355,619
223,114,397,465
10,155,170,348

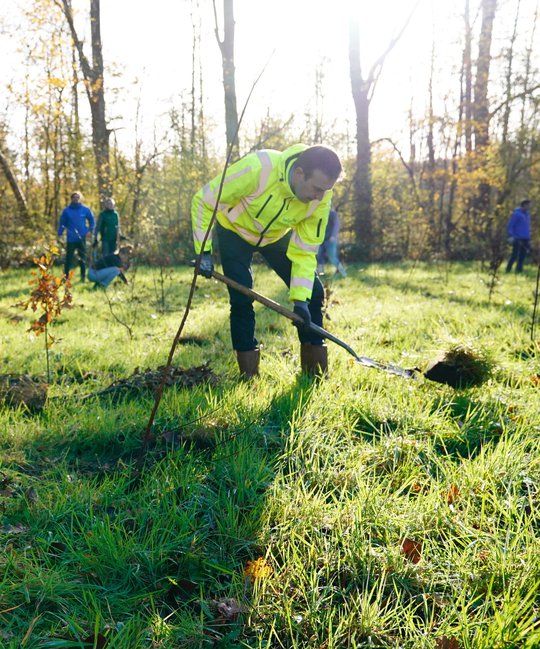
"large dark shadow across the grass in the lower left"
0,370,316,648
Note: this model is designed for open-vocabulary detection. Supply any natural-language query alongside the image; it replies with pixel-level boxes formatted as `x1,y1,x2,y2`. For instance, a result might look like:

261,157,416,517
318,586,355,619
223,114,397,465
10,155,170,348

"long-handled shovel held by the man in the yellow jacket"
212,270,417,379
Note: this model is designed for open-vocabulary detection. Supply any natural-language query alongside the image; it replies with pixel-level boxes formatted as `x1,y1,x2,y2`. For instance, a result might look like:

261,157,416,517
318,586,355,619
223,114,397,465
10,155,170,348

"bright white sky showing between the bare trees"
0,0,538,157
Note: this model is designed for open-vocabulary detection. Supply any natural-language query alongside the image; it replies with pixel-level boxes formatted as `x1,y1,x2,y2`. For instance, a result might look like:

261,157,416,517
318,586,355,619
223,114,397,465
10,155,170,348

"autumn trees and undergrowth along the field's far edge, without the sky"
0,0,540,266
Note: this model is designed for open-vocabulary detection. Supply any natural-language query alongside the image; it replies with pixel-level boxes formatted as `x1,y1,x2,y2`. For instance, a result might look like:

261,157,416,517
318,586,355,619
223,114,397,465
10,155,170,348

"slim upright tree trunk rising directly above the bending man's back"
213,0,239,158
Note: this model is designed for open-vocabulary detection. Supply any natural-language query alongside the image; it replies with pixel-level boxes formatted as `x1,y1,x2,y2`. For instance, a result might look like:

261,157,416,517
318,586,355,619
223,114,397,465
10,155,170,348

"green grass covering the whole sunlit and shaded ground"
0,264,540,649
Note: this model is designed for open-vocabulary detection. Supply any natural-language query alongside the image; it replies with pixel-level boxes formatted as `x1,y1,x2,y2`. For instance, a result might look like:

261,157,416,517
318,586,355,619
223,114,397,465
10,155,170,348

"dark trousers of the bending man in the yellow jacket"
216,223,324,352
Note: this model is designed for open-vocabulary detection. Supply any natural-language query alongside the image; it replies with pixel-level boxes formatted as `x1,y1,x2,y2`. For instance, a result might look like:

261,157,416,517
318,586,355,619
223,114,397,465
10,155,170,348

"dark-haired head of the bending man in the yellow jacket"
290,146,342,203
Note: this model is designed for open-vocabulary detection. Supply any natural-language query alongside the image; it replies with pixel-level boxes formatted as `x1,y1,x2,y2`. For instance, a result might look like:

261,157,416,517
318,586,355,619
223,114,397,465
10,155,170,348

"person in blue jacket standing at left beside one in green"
58,192,96,282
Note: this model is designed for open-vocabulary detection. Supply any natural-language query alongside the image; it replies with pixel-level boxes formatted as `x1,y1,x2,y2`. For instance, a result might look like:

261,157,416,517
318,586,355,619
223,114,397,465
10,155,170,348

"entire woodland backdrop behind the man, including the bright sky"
0,0,540,270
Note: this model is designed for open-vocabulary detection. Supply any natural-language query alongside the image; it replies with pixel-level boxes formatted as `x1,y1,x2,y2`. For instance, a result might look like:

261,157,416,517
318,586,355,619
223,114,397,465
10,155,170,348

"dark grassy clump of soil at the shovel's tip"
424,345,493,388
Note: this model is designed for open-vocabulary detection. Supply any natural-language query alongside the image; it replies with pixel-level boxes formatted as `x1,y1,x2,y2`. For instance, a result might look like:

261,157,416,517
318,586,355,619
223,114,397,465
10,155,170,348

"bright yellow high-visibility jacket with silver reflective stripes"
191,144,332,300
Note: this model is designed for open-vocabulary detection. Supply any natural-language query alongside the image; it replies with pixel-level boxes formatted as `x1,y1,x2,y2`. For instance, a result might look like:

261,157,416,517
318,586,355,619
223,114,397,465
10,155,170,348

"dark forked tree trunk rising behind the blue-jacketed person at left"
61,0,113,204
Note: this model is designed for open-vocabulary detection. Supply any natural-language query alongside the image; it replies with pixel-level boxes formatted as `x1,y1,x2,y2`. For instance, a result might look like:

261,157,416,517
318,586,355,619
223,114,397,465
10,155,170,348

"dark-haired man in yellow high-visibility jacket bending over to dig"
191,144,342,378
